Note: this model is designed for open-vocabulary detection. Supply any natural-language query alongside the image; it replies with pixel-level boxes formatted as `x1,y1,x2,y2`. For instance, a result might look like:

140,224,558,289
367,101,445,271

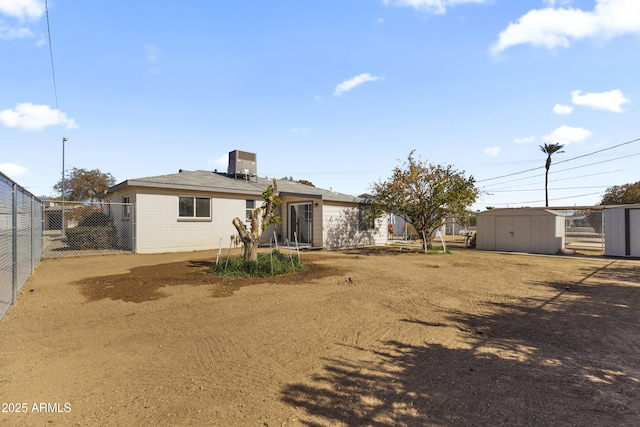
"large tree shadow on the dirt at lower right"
281,262,640,427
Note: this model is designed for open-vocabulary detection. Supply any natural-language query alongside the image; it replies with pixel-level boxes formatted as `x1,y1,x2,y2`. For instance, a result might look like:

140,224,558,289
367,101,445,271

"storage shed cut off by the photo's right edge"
604,205,640,257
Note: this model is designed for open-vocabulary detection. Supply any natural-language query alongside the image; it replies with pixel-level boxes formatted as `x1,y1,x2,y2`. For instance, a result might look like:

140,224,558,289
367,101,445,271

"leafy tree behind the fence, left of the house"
53,168,116,202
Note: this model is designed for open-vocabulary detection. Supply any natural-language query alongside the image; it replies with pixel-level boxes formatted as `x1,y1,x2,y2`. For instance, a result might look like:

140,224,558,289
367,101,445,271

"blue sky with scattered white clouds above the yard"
0,0,640,210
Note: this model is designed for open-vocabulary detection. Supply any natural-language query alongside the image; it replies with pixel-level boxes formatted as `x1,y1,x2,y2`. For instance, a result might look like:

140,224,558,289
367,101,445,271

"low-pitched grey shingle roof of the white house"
98,170,363,203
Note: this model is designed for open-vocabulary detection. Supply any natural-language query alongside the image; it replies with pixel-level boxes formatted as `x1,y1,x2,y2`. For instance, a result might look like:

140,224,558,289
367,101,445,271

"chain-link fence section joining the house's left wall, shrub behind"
43,200,135,258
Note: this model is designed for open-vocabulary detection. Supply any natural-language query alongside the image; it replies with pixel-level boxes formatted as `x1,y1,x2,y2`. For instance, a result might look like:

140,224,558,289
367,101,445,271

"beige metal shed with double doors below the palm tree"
476,208,565,254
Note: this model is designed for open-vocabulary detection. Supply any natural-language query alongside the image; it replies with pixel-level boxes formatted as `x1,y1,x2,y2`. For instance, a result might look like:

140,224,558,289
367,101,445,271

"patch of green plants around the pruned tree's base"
210,250,306,277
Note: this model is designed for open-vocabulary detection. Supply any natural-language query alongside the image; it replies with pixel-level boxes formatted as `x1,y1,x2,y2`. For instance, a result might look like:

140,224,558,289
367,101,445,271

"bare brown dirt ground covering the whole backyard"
0,248,640,427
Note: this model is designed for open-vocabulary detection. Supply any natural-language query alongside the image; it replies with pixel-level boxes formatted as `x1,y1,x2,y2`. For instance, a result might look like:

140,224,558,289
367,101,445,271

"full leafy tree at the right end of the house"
371,151,480,249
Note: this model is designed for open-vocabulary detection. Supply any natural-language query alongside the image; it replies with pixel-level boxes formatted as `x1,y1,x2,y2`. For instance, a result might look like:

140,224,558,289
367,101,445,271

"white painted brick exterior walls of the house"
105,187,387,253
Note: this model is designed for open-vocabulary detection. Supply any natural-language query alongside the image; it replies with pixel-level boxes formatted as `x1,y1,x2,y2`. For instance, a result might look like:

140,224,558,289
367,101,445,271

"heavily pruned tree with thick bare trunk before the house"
232,178,282,262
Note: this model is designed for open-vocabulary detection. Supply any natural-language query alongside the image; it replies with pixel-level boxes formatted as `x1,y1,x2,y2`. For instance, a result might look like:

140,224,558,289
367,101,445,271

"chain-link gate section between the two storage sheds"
554,206,605,253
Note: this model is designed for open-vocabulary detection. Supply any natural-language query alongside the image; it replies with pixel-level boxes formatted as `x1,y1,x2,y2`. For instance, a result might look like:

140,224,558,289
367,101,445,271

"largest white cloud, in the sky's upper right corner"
491,0,640,54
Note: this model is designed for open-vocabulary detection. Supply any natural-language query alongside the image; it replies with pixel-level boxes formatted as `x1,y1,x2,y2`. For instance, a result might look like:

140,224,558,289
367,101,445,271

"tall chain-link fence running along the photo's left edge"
0,173,42,319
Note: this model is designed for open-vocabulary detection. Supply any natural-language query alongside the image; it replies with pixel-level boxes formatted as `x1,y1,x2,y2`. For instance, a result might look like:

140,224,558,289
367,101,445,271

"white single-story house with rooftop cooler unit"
100,150,388,253
